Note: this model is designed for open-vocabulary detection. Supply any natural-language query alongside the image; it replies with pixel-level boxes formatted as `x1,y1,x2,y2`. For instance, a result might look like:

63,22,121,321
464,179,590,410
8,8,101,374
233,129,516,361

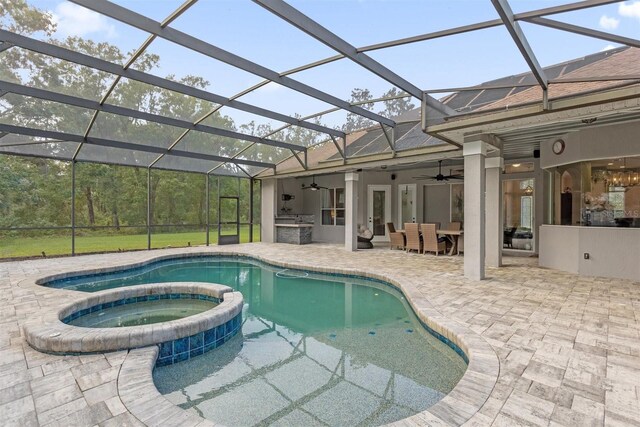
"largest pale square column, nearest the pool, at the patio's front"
462,141,487,280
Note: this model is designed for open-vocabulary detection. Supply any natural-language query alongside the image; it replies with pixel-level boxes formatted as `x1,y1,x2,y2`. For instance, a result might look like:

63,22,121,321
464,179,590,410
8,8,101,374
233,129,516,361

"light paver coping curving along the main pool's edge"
22,250,500,426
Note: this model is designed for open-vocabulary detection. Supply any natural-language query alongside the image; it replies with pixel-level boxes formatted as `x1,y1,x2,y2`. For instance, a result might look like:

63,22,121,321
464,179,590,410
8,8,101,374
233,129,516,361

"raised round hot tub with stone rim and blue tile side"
24,282,244,366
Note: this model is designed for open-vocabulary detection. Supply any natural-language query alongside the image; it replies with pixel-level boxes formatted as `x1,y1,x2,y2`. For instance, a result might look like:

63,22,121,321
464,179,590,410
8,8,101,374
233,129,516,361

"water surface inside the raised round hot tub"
68,299,218,328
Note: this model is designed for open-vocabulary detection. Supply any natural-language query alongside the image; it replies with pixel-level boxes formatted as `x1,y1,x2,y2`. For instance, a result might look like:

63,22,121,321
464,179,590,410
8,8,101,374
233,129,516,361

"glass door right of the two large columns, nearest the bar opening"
502,178,535,252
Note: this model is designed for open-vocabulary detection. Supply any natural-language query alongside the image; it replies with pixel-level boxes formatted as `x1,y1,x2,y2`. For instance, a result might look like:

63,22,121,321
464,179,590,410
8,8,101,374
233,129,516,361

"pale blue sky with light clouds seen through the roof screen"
28,0,640,126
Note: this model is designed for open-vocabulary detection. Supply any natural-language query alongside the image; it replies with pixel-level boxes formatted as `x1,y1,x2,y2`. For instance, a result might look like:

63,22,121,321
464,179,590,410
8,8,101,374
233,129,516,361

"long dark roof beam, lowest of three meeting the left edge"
0,123,275,169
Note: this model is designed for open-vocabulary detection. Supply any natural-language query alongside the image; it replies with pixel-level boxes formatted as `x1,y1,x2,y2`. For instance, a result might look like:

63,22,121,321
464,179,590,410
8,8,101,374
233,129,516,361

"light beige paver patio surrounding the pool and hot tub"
0,243,640,426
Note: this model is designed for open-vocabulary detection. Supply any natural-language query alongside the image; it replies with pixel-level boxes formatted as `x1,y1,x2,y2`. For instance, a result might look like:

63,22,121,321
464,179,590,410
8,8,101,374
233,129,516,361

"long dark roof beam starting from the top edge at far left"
70,0,395,127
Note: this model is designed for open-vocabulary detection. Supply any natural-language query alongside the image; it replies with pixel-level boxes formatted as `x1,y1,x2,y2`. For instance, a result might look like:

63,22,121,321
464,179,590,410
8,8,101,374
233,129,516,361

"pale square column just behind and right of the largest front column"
484,157,504,267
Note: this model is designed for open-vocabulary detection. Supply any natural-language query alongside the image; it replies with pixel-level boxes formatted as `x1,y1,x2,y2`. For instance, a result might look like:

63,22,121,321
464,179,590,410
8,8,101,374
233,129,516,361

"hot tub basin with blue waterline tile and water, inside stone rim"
62,294,220,328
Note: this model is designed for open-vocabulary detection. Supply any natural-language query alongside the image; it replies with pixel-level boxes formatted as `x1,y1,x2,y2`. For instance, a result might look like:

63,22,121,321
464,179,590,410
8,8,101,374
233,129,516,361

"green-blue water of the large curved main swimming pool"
48,257,466,426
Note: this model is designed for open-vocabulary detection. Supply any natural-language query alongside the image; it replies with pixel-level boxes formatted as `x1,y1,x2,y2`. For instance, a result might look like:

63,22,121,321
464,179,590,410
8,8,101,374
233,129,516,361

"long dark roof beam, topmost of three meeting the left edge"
0,28,344,137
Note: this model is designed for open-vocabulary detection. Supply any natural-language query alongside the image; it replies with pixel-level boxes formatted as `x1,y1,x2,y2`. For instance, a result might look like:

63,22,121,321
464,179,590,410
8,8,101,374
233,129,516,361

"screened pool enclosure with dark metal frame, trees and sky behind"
0,0,640,258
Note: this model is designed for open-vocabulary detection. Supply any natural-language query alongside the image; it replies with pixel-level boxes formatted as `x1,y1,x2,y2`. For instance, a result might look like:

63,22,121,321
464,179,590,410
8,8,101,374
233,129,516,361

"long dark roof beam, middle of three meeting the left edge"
0,80,307,151
